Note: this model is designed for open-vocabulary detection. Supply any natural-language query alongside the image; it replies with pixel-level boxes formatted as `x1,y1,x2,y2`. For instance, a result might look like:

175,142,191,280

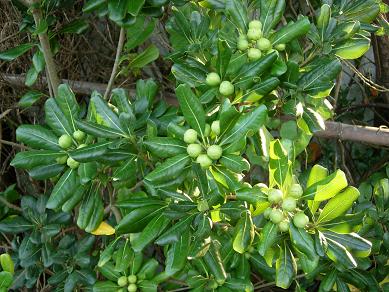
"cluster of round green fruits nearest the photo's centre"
184,121,223,169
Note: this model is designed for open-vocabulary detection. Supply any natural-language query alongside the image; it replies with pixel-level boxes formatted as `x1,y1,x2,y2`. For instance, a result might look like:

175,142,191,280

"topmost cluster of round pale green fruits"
237,20,285,61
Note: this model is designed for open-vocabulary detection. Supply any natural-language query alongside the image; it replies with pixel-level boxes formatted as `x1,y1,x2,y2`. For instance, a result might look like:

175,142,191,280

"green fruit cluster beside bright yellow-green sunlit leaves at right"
264,184,309,232
